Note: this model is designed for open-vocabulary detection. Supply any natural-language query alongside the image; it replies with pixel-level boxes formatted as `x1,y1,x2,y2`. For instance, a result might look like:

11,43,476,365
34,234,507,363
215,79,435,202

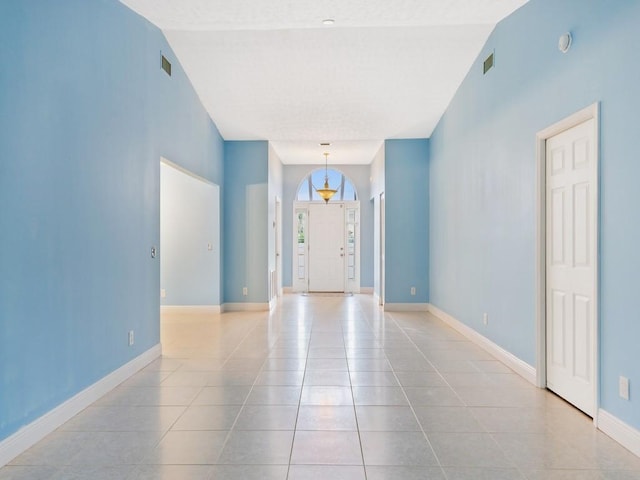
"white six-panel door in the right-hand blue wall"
546,119,597,416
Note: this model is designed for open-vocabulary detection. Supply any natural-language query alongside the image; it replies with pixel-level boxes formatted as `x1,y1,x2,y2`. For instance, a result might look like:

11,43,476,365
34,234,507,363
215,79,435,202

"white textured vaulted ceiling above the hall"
121,0,527,164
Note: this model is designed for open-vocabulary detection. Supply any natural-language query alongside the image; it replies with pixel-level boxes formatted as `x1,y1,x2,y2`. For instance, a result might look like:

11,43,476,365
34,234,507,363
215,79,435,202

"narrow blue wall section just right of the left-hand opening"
222,141,269,303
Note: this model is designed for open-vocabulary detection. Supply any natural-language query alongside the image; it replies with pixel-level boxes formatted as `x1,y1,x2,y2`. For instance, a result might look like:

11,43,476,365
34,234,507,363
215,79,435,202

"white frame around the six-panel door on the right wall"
536,102,600,426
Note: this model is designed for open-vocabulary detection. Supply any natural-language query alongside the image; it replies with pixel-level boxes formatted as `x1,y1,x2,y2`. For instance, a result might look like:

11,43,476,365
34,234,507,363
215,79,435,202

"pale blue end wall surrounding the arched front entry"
282,165,373,288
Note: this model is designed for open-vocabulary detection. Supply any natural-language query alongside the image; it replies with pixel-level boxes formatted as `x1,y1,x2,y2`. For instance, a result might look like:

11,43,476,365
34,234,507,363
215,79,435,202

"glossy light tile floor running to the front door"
0,295,640,480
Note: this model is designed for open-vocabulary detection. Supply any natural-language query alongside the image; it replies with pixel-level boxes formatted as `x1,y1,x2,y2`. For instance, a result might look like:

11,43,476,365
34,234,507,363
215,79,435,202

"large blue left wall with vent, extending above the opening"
0,0,223,440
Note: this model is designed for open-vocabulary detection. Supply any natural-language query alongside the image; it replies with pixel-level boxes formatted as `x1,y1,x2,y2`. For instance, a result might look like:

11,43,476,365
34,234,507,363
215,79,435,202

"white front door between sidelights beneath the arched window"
308,203,345,292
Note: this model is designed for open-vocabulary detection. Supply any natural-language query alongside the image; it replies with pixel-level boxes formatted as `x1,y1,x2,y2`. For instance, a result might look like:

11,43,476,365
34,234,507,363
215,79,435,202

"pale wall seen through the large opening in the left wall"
160,163,220,305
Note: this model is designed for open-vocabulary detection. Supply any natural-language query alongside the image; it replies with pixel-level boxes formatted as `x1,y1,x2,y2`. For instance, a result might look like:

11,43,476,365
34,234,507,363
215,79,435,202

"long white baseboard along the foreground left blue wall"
0,344,162,468
